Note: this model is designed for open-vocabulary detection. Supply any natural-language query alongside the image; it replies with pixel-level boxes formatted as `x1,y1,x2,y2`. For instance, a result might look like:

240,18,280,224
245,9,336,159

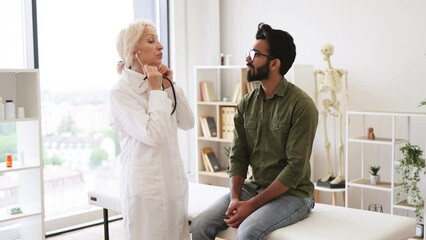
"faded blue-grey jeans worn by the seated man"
191,189,315,240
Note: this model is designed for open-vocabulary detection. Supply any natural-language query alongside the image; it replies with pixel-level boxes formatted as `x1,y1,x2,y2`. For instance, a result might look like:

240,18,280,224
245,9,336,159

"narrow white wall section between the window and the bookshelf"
170,0,220,181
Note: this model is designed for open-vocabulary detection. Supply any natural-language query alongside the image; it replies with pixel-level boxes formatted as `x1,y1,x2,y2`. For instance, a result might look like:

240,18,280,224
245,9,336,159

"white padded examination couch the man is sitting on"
88,183,416,240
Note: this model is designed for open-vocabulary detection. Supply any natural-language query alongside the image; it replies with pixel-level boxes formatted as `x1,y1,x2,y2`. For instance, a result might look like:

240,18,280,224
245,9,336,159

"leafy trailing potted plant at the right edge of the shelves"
396,143,426,221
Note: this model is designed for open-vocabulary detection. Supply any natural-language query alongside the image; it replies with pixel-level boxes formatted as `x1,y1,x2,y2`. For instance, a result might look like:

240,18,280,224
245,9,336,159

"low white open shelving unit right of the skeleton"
345,111,426,219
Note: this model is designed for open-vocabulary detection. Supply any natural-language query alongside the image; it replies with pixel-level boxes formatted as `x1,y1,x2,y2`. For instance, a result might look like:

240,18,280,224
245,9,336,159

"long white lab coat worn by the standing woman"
111,69,194,240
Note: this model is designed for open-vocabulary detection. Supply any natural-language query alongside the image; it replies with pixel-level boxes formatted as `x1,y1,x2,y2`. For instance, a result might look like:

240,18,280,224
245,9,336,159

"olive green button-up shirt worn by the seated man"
227,78,318,197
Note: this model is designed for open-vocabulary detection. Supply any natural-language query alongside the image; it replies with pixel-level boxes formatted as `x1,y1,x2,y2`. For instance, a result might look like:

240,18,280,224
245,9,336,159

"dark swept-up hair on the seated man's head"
256,22,296,75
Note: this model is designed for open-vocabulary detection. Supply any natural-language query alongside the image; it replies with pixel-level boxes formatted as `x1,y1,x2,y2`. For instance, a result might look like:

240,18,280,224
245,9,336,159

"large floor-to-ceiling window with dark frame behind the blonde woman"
0,0,169,234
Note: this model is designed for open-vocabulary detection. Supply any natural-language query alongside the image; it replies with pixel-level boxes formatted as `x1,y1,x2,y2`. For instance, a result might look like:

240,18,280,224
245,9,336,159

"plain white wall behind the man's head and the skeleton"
171,0,426,206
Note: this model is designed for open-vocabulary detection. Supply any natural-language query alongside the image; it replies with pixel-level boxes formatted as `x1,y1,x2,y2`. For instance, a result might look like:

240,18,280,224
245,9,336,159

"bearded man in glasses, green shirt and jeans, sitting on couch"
191,23,318,240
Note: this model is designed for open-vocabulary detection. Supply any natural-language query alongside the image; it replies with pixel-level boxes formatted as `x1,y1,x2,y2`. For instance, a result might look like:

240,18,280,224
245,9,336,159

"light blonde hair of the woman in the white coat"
117,19,156,73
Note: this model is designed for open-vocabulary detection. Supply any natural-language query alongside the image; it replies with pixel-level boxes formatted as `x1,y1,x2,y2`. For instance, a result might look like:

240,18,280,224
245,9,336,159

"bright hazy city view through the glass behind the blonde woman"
37,0,133,220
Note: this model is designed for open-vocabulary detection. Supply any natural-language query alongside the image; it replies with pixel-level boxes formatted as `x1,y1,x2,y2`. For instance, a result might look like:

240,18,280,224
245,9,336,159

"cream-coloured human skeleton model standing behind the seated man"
314,44,348,184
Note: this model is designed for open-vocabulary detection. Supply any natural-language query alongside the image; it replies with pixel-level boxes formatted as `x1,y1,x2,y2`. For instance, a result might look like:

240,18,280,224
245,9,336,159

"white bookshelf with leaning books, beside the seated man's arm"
195,66,247,186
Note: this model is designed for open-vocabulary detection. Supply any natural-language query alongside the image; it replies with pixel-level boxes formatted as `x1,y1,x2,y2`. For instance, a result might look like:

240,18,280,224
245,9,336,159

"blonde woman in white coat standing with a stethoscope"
111,20,194,240
